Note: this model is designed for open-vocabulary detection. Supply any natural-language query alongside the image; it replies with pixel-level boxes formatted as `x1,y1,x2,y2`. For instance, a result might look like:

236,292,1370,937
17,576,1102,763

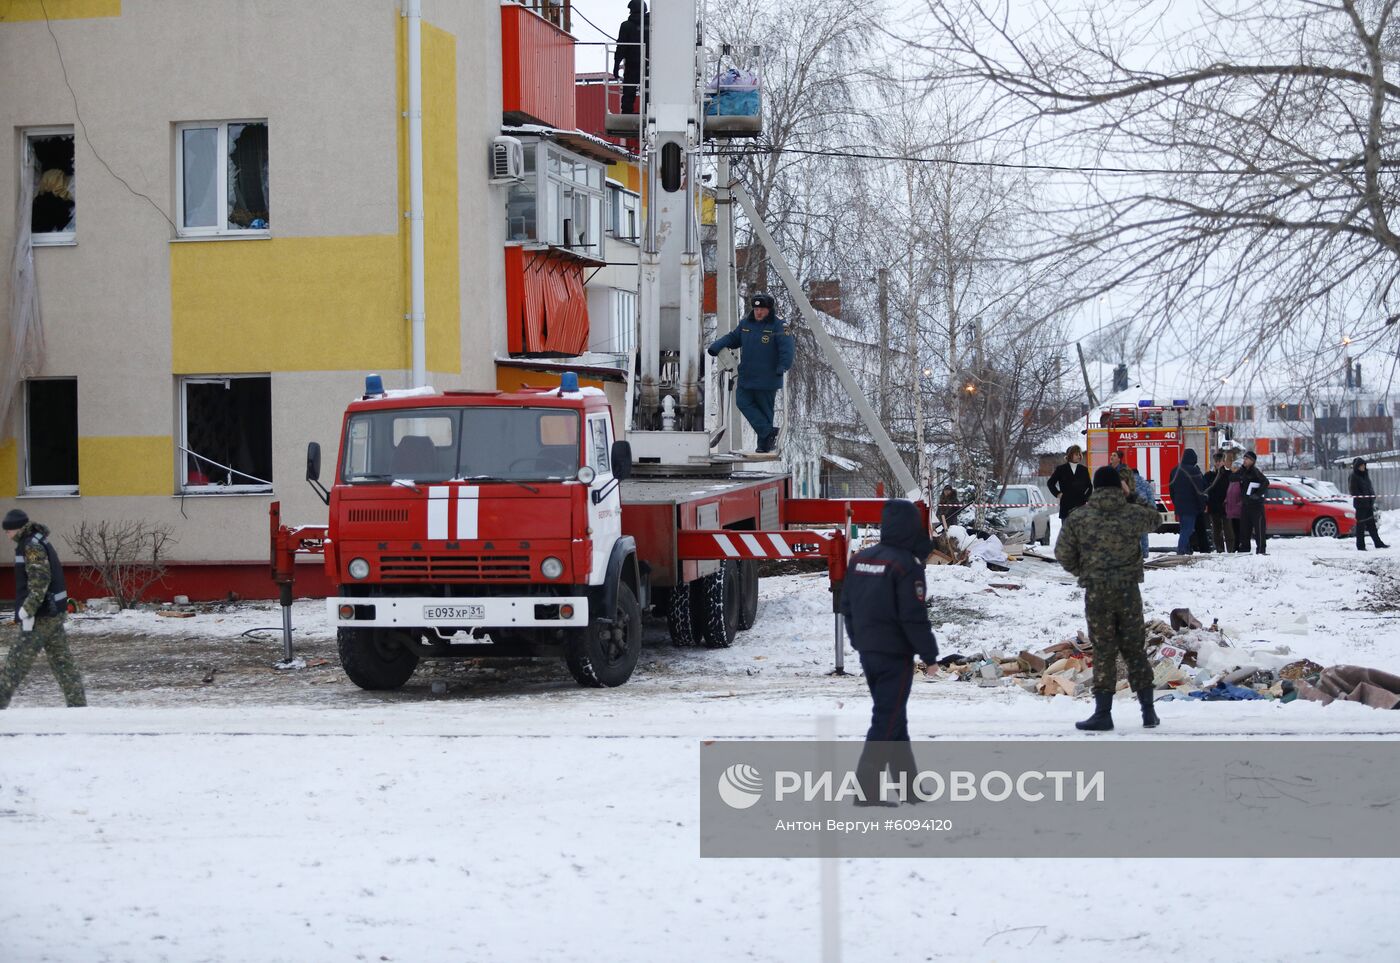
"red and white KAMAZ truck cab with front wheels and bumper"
308,375,644,689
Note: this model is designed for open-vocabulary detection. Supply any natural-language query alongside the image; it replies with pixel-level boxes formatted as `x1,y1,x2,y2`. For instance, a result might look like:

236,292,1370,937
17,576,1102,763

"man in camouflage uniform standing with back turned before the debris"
1054,465,1162,732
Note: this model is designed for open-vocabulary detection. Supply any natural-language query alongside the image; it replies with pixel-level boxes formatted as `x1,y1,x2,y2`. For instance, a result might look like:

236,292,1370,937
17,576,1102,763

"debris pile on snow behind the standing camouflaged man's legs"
923,604,1400,708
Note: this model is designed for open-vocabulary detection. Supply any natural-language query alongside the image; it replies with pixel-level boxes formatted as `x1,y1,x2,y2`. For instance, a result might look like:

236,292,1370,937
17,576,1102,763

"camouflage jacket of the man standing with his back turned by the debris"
1054,488,1162,588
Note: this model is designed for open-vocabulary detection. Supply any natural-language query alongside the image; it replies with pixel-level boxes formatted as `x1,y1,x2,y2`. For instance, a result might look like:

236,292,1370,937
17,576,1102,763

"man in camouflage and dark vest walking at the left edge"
0,508,87,708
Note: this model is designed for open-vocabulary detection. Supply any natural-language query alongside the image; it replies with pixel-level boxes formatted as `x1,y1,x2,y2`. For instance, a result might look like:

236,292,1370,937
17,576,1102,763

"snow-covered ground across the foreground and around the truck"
0,518,1400,963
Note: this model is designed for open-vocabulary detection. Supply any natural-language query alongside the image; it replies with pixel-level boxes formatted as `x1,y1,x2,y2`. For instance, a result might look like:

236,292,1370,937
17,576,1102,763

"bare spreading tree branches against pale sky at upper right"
921,0,1400,389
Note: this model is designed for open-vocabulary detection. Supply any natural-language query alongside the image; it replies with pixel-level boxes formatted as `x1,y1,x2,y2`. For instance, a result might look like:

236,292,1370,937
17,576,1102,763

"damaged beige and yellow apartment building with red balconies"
0,0,624,598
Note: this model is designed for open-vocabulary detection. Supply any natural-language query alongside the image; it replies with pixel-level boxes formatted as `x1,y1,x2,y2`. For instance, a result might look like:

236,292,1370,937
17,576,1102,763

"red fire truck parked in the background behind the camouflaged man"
1085,399,1218,528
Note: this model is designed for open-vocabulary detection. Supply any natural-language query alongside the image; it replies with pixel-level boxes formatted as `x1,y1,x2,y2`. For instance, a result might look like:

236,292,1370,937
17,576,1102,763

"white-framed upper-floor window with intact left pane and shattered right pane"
175,120,272,237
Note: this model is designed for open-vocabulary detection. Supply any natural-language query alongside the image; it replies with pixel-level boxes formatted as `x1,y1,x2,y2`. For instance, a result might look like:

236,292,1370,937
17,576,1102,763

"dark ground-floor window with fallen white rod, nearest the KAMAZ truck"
181,375,272,493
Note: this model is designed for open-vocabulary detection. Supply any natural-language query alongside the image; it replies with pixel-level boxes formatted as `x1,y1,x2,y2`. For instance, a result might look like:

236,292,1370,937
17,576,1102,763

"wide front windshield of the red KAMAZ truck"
340,407,580,484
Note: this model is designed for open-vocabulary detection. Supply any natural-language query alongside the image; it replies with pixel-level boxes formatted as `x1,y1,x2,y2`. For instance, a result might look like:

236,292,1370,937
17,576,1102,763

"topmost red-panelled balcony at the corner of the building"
501,0,577,130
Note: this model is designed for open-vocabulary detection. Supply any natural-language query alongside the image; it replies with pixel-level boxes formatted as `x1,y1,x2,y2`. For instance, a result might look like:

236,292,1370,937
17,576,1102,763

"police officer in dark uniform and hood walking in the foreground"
841,498,938,806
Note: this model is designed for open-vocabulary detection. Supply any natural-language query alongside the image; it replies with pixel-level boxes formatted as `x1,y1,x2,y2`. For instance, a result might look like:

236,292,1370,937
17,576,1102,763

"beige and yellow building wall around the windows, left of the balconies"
0,0,504,576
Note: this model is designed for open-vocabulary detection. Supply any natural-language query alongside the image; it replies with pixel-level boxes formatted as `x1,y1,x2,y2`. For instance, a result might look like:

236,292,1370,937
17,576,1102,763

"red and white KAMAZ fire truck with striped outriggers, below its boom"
272,374,882,689
